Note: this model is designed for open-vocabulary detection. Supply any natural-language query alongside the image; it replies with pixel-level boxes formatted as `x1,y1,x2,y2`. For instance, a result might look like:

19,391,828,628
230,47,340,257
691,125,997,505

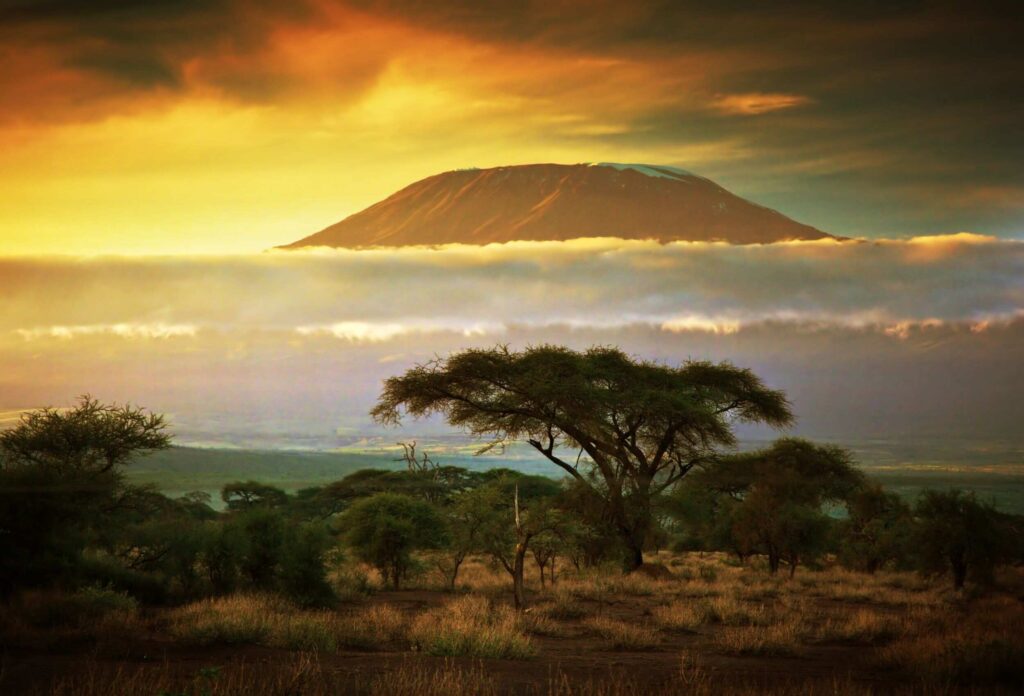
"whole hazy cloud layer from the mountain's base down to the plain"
0,235,1024,445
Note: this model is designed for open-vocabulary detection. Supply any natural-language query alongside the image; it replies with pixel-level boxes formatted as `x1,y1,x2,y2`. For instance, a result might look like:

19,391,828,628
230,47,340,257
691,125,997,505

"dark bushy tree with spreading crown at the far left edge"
0,396,170,595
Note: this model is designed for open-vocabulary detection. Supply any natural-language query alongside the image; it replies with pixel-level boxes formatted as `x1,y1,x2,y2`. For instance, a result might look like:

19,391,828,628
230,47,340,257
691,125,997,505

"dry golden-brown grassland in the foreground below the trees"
0,553,1024,696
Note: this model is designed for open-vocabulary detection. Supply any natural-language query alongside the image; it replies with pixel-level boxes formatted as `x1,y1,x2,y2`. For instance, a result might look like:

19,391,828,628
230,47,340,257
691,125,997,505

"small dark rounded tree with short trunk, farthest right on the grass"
913,490,1013,590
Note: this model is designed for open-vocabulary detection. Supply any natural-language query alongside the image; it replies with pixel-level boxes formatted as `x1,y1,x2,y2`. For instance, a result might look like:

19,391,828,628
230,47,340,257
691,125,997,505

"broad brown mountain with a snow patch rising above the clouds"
283,163,831,249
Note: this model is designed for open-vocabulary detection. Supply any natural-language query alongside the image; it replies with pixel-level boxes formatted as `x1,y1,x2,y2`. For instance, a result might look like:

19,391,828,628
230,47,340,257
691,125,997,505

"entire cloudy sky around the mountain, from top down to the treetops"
0,0,1024,447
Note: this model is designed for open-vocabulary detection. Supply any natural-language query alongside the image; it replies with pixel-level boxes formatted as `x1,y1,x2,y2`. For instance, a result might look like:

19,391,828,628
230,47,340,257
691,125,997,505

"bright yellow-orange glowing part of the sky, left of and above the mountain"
0,12,737,254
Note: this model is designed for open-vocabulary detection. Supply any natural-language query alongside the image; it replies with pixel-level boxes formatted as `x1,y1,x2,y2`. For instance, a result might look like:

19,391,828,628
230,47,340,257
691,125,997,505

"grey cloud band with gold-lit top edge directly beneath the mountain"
0,234,1024,341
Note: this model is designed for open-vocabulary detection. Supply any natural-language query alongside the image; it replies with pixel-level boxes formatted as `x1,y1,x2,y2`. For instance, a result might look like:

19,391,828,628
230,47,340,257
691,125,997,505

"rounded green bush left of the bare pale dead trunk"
342,493,447,590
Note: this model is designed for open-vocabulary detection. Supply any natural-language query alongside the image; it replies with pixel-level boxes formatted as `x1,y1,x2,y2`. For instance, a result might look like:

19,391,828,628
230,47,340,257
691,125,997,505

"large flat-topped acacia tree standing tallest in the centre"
372,345,793,570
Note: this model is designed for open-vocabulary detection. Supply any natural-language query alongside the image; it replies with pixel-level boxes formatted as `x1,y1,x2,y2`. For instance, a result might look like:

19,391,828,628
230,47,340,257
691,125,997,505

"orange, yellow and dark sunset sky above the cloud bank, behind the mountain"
0,0,1024,255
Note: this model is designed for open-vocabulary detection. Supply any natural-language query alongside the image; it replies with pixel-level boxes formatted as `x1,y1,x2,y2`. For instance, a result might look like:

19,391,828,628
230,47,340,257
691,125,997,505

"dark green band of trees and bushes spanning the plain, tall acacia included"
0,346,1024,606
